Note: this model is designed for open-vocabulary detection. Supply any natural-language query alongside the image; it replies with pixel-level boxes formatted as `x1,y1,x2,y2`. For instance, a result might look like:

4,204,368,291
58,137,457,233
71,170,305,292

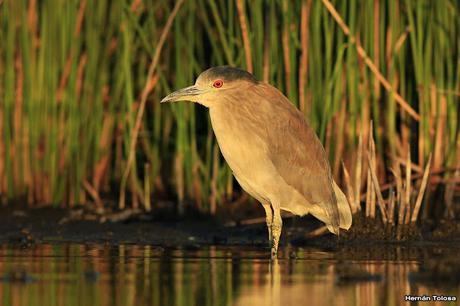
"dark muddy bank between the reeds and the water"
0,207,460,248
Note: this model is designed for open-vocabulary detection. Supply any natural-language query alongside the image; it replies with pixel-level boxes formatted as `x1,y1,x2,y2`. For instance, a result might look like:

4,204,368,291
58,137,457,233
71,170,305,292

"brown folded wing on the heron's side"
257,84,340,230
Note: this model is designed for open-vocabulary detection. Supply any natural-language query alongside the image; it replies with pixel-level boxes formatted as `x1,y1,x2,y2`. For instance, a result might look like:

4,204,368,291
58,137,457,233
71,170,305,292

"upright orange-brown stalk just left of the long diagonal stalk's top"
299,0,312,114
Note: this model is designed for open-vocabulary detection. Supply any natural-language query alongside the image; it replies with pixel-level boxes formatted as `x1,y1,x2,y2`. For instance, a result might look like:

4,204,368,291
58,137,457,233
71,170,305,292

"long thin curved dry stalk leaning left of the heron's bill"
118,0,184,209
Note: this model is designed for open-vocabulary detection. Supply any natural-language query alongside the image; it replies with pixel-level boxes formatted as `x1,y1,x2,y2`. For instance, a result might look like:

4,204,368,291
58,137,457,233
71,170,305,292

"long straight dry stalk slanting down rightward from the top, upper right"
321,0,420,121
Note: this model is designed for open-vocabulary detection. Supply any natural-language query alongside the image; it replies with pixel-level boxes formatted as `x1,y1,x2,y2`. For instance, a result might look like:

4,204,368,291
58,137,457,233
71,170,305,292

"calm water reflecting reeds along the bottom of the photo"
0,244,460,306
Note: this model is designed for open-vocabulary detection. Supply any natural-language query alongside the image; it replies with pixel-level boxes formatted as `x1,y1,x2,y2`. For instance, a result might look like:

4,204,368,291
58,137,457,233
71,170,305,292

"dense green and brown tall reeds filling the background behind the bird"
0,0,460,220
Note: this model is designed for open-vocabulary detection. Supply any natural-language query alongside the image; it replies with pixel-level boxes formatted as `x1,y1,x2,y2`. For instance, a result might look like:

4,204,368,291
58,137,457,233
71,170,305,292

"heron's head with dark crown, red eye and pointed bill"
161,66,258,107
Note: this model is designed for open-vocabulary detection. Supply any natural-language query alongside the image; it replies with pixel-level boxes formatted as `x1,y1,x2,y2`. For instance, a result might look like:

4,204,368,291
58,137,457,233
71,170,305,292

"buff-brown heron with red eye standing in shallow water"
161,66,352,258
